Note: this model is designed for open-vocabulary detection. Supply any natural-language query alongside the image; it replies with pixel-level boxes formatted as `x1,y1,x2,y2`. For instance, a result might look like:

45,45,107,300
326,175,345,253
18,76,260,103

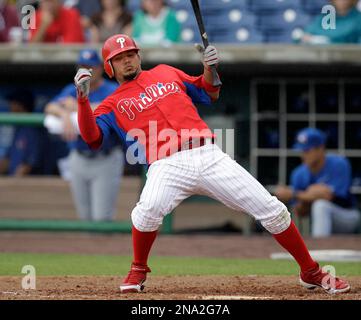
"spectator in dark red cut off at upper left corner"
0,0,20,42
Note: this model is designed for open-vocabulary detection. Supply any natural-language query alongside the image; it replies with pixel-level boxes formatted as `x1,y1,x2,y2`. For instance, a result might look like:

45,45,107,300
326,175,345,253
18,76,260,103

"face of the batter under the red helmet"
112,51,141,82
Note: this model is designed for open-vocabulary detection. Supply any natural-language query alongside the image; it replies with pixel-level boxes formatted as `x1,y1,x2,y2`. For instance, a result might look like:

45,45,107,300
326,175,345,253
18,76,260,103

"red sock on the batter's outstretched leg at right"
273,221,317,271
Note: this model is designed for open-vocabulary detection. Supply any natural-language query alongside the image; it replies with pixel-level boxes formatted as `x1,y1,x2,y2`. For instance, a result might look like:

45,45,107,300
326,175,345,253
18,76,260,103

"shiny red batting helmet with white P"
102,34,139,78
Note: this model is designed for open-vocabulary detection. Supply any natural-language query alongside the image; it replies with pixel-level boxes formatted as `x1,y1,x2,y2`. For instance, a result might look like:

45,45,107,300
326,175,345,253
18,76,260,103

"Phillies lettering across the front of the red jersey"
117,82,181,120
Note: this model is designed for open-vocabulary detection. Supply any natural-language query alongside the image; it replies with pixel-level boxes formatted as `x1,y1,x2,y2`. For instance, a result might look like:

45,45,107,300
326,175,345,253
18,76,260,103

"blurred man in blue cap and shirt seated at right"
275,128,360,237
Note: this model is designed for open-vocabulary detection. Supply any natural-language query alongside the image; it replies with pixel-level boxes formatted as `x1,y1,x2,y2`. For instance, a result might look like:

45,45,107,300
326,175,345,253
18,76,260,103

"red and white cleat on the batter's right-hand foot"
300,265,351,294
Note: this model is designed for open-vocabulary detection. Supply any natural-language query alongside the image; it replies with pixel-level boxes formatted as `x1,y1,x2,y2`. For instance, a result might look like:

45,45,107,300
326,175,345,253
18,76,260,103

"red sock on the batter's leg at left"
132,226,158,266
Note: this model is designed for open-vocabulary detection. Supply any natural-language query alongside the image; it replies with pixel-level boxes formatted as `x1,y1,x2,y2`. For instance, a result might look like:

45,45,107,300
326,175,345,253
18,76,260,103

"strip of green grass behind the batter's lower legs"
0,253,361,276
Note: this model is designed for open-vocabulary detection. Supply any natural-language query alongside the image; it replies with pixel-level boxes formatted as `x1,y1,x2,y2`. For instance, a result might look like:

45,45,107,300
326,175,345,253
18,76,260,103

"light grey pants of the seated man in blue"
311,199,360,237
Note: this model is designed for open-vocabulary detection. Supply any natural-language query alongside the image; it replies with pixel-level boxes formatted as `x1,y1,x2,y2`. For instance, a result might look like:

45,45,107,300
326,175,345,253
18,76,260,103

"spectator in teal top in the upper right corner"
302,0,361,44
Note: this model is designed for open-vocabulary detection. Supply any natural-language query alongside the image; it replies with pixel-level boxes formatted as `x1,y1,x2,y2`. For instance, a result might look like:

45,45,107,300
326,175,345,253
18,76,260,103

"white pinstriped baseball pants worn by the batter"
132,144,291,234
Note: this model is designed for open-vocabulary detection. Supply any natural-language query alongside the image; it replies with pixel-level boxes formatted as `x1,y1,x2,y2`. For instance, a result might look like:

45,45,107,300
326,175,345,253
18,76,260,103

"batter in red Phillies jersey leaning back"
74,34,350,293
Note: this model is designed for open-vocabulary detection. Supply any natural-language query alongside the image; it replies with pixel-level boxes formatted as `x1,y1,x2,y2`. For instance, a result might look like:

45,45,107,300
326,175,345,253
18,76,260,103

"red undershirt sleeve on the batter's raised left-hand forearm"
78,98,103,149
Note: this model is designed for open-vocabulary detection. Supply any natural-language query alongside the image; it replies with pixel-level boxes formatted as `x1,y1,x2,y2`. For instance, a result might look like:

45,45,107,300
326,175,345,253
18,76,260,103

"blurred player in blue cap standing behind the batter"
45,49,124,221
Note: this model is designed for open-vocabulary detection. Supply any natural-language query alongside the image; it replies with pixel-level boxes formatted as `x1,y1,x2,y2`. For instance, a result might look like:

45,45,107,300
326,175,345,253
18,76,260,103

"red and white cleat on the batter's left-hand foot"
120,263,151,293
